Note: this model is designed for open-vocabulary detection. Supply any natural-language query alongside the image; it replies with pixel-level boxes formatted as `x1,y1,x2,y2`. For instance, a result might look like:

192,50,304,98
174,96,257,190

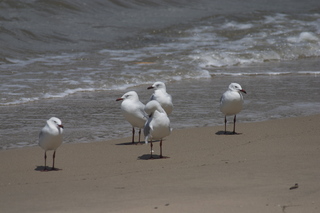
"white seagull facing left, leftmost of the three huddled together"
116,91,148,144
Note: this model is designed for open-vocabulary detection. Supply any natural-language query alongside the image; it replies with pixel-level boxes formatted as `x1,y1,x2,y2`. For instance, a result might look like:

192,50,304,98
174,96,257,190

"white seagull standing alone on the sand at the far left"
39,117,63,171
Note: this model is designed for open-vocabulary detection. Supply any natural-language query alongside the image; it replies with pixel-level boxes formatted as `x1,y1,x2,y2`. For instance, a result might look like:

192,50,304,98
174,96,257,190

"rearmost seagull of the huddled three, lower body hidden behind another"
148,81,173,115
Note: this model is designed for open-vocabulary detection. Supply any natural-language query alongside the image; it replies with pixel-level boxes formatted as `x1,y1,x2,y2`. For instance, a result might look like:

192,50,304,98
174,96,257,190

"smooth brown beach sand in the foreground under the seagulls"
0,115,320,213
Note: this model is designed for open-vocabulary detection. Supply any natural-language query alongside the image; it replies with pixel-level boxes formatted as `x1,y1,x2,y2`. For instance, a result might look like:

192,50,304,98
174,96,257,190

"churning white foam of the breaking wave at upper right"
189,14,320,68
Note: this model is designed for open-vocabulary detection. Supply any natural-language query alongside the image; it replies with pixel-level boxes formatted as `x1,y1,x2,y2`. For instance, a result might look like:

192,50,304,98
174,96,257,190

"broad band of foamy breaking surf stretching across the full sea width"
0,13,320,106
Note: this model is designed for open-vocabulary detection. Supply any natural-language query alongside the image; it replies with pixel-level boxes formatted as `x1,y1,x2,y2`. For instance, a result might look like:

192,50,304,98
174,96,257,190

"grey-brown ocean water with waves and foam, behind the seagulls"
0,0,320,149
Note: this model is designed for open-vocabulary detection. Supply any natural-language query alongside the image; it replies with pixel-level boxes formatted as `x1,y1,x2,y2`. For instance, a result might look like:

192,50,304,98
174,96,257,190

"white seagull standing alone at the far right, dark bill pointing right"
220,83,247,134
